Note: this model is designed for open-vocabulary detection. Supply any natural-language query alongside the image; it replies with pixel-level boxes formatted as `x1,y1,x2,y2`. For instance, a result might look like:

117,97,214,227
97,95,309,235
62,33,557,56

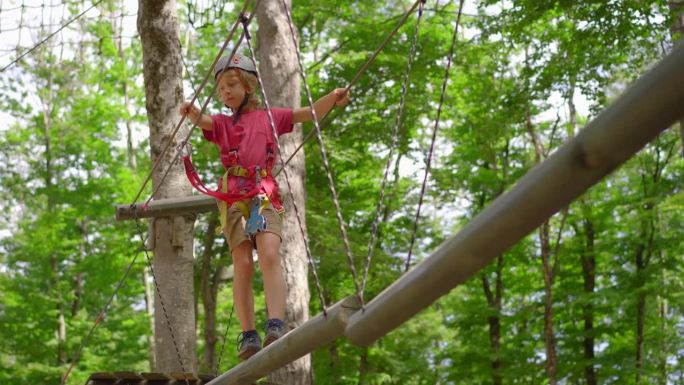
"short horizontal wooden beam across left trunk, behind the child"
116,195,218,221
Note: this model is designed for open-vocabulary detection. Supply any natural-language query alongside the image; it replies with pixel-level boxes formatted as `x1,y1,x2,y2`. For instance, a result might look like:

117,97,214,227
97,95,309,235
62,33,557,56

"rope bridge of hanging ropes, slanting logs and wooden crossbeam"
17,0,684,385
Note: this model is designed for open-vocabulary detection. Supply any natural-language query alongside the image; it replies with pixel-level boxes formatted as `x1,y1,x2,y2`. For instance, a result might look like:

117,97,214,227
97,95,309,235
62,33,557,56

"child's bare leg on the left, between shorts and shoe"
231,241,256,331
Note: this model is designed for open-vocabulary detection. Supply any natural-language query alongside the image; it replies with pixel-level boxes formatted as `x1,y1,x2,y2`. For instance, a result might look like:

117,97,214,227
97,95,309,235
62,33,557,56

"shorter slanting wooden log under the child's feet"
207,296,361,385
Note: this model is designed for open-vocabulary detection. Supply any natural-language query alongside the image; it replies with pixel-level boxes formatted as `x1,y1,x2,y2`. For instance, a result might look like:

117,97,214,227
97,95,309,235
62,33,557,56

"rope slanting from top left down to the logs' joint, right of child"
282,0,363,303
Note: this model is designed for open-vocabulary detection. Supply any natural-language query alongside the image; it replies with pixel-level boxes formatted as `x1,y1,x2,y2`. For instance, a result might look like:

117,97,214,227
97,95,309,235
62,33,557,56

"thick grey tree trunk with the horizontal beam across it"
138,0,196,372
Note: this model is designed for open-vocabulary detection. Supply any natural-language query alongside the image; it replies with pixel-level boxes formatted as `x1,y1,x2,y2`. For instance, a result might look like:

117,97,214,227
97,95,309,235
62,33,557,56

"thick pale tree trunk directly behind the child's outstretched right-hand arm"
257,0,312,385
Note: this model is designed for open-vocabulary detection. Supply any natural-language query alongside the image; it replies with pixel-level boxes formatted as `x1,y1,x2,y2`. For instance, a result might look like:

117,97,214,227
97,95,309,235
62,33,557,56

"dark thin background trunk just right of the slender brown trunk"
581,210,597,385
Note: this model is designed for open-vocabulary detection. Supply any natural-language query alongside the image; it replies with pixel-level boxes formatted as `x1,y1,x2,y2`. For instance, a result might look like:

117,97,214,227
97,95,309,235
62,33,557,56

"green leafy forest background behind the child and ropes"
0,0,684,385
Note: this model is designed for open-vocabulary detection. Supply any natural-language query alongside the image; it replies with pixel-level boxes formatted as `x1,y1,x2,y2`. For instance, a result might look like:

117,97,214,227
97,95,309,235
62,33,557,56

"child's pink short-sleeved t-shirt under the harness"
202,108,293,193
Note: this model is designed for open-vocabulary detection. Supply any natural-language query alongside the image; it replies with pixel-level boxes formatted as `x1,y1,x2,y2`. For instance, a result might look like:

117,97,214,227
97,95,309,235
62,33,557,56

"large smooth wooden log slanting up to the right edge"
345,39,684,346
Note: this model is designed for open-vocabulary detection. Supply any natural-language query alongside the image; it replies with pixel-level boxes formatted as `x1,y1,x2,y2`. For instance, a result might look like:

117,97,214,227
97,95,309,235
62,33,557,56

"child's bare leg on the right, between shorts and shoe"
256,232,287,320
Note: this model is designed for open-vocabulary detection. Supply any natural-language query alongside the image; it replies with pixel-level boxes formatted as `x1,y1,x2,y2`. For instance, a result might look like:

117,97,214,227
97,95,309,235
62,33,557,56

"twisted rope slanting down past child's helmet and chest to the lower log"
244,15,328,317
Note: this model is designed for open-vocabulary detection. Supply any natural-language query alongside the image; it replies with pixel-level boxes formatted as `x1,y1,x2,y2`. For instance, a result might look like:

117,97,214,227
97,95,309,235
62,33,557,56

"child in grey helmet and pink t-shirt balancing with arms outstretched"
180,54,349,360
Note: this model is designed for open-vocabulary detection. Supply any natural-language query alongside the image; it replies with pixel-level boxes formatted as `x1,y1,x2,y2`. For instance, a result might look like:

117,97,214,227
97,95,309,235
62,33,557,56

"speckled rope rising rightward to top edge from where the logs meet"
361,2,425,295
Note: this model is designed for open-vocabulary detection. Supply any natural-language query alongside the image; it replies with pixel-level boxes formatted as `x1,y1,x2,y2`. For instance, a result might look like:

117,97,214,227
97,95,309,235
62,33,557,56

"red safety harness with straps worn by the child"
183,115,285,239
